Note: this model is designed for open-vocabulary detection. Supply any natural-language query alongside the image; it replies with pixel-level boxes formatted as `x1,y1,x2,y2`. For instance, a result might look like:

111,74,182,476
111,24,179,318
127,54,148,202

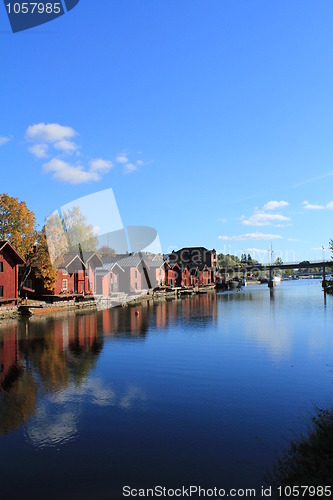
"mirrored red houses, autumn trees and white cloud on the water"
0,293,218,440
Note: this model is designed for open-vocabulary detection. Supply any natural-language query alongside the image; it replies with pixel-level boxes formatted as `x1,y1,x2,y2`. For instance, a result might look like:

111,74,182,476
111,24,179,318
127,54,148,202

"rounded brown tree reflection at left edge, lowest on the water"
0,366,37,434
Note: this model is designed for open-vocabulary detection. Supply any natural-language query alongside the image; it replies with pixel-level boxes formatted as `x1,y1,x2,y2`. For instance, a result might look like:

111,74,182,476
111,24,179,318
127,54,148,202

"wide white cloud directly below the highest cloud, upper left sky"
43,158,101,184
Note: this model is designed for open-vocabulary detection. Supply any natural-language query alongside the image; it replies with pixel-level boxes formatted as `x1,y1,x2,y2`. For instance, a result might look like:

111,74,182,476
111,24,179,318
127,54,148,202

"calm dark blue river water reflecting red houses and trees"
0,280,333,500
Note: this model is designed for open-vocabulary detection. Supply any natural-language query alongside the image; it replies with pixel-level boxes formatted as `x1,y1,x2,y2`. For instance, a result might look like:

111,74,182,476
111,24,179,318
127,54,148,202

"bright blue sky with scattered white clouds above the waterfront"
0,0,333,261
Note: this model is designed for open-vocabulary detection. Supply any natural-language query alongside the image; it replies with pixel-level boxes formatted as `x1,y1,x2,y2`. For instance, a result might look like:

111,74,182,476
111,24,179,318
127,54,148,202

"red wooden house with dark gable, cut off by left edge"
0,241,24,306
